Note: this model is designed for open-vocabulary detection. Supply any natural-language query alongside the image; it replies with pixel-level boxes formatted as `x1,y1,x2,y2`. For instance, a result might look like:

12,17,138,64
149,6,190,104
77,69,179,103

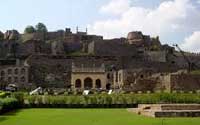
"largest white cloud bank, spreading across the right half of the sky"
89,0,200,41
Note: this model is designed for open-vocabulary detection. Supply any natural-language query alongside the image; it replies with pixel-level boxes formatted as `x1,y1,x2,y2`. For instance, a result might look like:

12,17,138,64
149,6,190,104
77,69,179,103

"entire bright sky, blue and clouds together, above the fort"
0,0,200,51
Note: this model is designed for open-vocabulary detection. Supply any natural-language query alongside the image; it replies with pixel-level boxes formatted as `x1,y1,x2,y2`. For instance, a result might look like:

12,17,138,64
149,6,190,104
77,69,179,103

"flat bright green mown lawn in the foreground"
0,109,200,125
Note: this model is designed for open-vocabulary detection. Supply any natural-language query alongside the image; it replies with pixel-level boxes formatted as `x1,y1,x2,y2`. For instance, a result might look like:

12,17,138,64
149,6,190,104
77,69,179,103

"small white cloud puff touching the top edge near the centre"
100,0,130,15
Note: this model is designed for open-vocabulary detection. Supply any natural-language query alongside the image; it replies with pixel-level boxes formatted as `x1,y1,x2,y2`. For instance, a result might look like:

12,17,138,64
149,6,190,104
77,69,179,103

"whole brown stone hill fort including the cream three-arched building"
0,28,200,92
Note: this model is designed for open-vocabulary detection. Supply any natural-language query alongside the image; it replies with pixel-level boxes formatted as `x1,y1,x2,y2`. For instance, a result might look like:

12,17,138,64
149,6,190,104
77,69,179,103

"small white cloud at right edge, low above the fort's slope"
181,31,200,53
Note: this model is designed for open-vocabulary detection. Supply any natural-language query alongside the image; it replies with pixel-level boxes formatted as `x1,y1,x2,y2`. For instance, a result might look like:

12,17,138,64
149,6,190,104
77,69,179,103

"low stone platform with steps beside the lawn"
132,104,200,117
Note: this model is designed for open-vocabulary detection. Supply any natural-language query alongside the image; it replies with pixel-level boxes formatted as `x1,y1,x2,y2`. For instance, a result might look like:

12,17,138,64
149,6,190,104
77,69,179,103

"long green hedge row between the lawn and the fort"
25,93,200,108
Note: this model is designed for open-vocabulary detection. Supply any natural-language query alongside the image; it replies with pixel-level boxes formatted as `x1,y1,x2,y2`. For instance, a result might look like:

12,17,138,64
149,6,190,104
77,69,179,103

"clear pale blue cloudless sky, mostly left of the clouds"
0,0,166,32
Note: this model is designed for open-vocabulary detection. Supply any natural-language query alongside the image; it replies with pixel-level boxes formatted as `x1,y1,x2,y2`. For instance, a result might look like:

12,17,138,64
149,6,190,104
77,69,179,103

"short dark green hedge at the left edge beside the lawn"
0,98,19,114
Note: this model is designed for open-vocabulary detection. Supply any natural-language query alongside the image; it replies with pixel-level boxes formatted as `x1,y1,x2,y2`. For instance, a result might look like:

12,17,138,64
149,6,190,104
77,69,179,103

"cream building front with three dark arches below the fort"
71,64,107,90
